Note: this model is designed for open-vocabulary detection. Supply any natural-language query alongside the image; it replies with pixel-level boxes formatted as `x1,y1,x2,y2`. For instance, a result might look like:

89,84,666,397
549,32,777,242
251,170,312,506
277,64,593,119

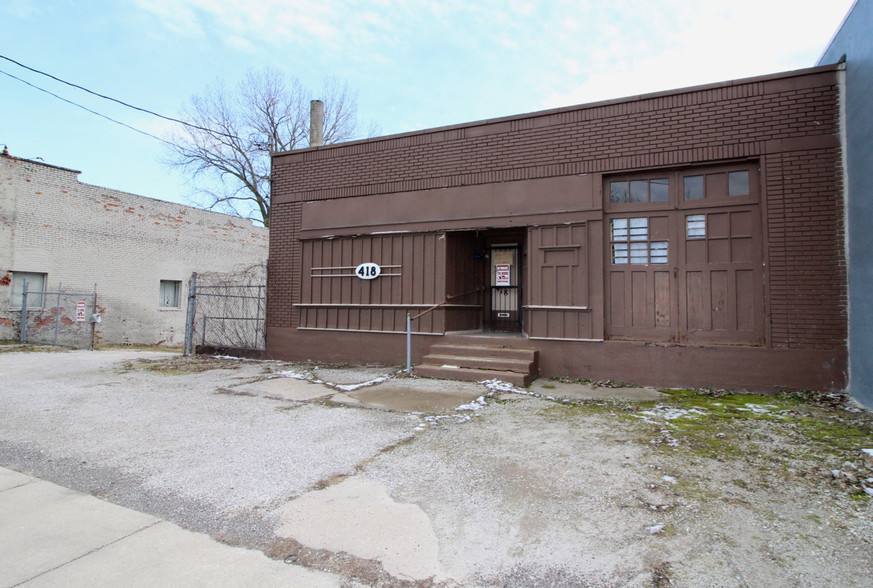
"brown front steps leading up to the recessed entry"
415,343,539,386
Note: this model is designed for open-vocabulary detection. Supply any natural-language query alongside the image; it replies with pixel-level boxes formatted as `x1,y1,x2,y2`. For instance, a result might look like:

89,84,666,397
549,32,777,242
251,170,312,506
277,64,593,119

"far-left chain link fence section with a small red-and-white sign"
20,280,100,349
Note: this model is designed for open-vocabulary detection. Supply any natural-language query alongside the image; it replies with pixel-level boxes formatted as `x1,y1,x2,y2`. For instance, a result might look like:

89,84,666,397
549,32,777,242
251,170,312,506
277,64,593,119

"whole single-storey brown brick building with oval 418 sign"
267,66,847,389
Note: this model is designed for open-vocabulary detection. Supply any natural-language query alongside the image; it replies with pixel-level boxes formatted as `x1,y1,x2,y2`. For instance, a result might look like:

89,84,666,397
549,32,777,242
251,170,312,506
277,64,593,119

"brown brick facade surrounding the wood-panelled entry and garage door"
268,66,847,387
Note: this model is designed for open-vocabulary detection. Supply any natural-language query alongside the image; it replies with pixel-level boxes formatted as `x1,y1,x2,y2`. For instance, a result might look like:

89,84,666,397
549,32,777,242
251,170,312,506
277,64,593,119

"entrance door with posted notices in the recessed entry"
486,243,521,332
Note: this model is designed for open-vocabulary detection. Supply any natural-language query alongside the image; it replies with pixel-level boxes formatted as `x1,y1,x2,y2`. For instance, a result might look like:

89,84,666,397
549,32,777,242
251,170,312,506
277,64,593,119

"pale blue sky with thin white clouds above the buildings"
0,0,852,211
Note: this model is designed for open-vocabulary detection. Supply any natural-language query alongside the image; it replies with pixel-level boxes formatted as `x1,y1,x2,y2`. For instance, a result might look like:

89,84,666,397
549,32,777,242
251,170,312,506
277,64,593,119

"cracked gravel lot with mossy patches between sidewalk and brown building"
0,348,873,587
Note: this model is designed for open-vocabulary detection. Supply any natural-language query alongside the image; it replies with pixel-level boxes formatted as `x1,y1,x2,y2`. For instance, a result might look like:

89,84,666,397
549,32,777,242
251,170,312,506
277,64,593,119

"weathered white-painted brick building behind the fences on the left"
0,155,269,346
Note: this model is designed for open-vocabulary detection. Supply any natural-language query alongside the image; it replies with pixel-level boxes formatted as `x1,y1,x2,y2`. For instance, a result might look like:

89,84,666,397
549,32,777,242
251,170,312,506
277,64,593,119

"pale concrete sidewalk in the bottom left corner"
0,468,343,588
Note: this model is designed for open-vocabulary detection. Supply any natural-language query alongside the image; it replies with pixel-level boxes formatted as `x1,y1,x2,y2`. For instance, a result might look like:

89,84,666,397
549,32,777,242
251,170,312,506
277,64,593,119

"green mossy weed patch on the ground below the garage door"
545,389,873,501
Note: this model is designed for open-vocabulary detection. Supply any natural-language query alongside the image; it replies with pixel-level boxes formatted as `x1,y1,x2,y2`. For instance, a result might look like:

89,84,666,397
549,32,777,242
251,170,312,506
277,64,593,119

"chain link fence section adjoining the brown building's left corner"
185,265,267,356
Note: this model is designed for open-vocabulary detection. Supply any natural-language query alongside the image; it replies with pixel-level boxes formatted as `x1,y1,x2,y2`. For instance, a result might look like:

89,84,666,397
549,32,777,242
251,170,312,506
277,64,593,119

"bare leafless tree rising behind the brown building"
169,69,375,227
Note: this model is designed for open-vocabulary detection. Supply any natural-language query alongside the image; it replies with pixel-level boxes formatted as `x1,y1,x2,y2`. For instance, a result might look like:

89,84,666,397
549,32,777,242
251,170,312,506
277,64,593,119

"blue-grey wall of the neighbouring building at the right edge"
819,0,873,408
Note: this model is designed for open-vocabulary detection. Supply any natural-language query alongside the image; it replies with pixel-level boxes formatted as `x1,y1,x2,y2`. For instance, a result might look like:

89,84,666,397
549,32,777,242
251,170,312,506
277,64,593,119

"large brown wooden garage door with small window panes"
604,164,764,344
